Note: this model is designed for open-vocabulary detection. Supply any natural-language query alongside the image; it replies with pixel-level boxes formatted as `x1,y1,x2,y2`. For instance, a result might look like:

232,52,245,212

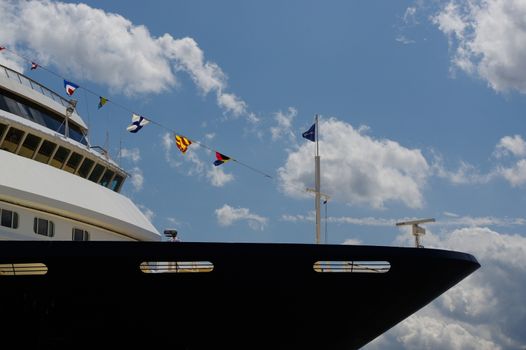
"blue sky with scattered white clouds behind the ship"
0,0,526,349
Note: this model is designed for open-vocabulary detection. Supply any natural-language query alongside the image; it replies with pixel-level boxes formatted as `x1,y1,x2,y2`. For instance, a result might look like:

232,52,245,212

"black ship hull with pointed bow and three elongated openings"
0,241,480,349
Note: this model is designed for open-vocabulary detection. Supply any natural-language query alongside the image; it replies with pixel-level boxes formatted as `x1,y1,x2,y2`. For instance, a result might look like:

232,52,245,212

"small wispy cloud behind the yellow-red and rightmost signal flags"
162,133,234,187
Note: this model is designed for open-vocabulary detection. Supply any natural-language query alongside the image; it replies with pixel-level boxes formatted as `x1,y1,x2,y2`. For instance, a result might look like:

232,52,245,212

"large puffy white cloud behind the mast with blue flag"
278,118,430,208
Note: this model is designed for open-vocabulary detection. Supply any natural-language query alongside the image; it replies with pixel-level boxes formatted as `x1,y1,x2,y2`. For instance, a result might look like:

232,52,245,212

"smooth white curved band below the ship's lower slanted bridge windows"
0,150,161,241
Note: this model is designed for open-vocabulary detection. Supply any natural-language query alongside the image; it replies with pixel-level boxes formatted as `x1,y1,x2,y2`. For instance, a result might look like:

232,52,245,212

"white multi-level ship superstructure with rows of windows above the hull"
0,65,161,241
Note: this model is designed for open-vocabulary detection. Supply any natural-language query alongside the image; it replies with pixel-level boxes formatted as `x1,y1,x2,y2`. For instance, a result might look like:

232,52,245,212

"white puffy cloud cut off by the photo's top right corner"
433,0,526,93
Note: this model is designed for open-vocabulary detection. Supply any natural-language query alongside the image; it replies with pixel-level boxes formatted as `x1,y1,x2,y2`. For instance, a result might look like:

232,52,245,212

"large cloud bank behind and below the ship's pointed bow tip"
366,227,526,350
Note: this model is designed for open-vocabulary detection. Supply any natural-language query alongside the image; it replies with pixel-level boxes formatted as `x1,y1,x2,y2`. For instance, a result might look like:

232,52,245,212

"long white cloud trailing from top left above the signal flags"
0,0,248,117
